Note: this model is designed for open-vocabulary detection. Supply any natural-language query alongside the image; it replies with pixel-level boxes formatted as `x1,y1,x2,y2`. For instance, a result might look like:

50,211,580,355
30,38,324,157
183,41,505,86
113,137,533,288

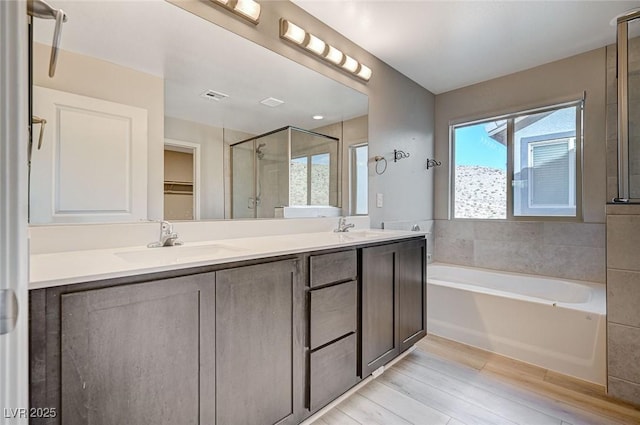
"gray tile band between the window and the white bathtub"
434,220,605,283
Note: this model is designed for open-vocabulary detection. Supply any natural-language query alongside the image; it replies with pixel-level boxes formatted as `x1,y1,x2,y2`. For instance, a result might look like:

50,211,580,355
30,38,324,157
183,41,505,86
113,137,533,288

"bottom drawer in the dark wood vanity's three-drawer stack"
309,334,358,411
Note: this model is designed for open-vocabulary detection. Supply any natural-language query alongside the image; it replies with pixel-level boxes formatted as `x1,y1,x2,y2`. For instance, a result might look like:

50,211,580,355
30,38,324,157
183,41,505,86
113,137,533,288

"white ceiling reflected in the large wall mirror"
32,0,368,134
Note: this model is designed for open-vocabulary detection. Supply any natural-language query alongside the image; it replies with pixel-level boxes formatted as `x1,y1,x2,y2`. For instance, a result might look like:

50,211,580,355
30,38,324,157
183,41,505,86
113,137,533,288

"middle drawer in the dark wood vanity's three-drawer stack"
310,280,358,350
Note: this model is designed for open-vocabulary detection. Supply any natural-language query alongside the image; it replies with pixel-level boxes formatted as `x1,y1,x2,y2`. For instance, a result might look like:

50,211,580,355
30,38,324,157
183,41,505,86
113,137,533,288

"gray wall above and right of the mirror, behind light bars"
169,0,434,227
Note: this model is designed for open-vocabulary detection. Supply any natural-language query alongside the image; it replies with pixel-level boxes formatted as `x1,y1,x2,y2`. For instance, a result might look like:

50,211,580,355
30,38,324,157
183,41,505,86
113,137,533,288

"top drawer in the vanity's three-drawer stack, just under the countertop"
309,249,358,287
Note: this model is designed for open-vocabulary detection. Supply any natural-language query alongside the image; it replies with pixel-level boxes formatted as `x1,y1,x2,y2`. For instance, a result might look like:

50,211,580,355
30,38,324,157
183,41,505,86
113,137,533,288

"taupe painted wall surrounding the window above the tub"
434,47,607,223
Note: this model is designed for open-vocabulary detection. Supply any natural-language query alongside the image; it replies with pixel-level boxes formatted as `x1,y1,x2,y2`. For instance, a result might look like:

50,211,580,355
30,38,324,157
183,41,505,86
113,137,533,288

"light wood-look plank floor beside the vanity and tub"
314,336,640,425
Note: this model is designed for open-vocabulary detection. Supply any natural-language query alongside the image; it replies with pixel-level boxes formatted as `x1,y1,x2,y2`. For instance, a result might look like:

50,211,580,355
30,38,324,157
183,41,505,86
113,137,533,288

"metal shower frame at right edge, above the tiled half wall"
613,11,640,204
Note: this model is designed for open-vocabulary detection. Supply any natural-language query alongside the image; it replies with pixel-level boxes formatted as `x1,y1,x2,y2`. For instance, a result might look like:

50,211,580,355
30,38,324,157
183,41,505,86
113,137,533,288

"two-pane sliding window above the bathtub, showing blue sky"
451,102,582,219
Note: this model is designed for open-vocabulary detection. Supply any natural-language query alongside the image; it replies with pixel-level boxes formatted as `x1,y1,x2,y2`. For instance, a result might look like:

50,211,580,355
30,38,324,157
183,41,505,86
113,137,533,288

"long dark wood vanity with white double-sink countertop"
30,231,426,425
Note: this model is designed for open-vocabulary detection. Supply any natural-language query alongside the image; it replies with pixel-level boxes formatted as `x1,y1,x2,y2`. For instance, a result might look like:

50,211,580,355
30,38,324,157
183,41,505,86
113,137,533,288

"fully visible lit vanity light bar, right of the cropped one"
278,18,372,81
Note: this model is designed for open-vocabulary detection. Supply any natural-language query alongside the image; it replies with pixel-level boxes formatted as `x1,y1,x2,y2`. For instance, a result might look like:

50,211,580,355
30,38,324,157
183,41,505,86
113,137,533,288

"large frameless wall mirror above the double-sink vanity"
29,0,368,224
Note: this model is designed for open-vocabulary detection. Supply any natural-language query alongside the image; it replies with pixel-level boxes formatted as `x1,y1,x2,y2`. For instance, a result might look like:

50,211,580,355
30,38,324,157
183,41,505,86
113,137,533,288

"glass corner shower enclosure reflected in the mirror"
231,126,339,218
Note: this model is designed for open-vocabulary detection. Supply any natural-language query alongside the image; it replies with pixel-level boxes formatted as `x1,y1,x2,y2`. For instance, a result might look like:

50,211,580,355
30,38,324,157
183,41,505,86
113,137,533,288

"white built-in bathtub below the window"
427,263,606,385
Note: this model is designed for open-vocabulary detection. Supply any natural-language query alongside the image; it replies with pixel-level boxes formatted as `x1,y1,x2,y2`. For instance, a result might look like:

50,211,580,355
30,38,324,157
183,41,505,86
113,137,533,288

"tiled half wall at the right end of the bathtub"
607,205,640,405
